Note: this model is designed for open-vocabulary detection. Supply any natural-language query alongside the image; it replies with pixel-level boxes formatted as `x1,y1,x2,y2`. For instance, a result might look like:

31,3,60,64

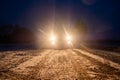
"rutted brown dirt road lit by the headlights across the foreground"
0,49,120,80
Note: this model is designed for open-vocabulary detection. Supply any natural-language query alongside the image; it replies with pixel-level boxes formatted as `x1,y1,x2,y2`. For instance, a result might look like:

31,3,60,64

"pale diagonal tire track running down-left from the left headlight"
11,50,51,74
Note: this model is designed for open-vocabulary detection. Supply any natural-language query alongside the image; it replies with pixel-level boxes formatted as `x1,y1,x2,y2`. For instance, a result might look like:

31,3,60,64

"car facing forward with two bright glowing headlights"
49,31,73,49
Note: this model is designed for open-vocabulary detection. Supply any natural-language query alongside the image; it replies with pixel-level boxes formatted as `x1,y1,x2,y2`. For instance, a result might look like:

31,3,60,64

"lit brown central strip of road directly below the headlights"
37,50,77,80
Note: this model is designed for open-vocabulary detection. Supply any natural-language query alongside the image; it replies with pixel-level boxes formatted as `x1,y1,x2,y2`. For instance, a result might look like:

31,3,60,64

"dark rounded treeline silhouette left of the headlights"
0,24,35,44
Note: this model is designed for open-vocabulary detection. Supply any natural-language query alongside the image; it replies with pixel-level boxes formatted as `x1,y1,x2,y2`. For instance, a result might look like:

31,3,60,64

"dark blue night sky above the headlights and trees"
0,0,120,39
